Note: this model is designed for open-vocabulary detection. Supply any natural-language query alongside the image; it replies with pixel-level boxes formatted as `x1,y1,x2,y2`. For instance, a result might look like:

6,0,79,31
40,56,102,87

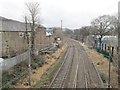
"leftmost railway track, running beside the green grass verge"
49,45,74,88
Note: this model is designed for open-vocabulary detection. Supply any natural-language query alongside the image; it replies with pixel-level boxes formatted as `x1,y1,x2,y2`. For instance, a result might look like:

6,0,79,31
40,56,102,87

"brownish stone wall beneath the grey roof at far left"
1,31,28,57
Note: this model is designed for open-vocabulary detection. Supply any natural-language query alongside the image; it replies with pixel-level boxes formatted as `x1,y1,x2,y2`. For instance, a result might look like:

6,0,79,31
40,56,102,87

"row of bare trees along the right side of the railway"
73,15,118,45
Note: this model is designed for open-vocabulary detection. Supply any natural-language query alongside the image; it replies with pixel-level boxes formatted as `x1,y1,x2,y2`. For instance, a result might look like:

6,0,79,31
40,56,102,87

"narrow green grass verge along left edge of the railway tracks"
31,44,67,88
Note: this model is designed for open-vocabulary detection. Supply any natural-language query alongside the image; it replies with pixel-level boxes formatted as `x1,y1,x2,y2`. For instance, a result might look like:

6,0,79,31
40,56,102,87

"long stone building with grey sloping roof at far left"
0,17,30,58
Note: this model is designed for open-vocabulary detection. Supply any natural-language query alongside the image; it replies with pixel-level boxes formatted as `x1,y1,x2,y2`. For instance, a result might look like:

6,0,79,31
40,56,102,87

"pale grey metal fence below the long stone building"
2,51,30,71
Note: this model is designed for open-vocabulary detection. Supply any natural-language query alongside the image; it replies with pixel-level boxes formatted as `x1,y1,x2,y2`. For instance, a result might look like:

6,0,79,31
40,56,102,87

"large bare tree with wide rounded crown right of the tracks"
91,15,114,47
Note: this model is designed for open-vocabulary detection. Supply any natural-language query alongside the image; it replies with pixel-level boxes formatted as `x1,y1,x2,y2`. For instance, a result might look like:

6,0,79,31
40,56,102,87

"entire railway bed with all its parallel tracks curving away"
49,40,104,89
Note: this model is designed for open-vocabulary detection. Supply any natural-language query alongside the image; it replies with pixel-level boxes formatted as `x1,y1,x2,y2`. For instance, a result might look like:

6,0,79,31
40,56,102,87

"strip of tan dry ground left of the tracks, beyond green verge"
14,44,67,88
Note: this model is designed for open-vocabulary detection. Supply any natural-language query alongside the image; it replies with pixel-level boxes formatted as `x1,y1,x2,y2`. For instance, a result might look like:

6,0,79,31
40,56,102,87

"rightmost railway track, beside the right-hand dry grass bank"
77,41,104,88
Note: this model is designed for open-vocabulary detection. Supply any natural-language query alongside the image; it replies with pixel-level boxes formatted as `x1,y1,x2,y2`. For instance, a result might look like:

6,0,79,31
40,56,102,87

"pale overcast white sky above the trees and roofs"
0,0,119,29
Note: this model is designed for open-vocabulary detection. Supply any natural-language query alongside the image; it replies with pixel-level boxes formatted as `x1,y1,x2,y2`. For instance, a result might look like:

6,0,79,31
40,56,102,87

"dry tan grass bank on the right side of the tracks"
82,44,118,88
